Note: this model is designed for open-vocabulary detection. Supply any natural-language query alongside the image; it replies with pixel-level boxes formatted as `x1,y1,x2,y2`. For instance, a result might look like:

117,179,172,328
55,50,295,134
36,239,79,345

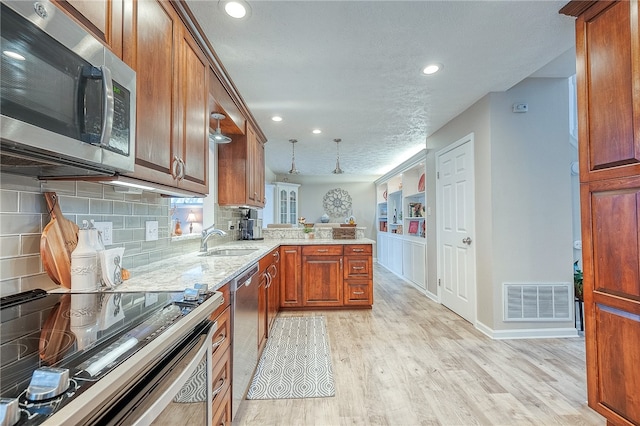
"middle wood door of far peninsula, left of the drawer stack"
302,256,343,307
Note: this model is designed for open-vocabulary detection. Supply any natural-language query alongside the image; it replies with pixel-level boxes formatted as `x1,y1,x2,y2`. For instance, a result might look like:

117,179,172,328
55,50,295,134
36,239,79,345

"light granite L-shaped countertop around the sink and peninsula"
115,238,374,291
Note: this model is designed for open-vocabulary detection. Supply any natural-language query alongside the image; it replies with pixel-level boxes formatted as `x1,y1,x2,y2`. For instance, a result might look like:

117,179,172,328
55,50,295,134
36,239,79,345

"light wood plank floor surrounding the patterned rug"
233,265,605,426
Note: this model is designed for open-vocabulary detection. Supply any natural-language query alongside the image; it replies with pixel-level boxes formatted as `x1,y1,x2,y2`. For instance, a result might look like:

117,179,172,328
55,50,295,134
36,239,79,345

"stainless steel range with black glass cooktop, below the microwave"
0,285,222,425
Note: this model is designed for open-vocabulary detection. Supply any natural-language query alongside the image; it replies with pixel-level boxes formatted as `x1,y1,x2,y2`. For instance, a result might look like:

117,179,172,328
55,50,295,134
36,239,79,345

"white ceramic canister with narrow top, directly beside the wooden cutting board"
71,229,98,291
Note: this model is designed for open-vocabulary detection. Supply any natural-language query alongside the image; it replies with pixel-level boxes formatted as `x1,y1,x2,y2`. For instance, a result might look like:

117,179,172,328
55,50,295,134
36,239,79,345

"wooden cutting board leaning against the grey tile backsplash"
40,192,78,288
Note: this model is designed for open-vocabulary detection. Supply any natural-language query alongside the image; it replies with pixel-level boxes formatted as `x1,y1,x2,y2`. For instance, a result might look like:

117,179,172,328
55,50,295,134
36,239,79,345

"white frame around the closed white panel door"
435,132,478,326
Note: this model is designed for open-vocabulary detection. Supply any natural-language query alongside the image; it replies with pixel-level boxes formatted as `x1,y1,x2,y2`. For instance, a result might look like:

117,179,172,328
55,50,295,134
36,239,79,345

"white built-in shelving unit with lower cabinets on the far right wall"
375,150,428,290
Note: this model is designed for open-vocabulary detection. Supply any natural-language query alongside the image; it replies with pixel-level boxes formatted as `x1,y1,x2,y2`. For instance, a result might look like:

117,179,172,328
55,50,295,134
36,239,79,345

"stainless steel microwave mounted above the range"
0,0,136,178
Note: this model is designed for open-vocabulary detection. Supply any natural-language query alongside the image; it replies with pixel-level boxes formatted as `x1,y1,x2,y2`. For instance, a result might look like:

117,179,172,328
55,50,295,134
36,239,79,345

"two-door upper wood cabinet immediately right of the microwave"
123,0,209,194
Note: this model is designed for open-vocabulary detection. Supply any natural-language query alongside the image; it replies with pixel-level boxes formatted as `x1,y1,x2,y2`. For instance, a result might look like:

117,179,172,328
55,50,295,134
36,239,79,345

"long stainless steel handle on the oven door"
132,321,218,425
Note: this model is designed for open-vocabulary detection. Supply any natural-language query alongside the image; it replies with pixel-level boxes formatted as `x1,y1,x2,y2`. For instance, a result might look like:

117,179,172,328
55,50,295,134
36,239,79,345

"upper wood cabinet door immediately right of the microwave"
123,0,181,185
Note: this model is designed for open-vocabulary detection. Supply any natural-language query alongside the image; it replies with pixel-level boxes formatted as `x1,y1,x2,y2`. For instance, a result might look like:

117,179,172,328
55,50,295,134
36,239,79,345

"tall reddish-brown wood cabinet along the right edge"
561,0,640,425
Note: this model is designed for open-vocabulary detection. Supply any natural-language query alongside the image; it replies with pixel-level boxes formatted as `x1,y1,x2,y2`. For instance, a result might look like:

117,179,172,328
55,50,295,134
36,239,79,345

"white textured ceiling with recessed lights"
187,0,574,179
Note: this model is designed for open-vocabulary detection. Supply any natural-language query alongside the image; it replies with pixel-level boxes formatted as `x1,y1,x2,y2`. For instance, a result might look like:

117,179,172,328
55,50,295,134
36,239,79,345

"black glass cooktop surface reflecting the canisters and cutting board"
0,285,212,424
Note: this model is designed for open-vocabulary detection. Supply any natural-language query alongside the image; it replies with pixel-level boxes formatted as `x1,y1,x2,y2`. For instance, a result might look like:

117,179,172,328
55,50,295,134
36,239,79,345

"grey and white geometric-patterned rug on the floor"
247,317,336,399
